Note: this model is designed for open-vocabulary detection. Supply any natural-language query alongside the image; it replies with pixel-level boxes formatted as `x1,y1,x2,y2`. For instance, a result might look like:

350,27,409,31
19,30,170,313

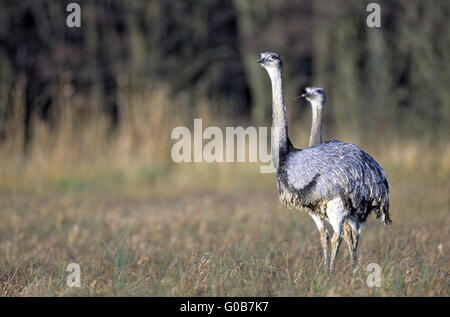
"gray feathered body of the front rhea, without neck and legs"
277,140,390,225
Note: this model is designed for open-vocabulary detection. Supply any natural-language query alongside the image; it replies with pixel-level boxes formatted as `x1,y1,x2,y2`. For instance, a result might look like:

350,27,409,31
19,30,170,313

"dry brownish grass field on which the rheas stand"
0,122,450,296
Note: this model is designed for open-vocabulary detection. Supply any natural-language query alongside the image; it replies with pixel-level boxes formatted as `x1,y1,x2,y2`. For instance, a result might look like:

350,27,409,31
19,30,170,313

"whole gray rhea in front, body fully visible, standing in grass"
258,52,391,270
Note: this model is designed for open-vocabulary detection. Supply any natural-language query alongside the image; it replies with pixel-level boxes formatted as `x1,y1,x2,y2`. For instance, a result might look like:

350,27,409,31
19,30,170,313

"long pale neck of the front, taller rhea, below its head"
269,69,290,169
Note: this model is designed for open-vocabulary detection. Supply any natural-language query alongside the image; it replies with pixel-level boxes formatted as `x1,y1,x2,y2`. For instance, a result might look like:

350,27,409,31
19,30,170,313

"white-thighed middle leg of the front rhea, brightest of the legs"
326,198,348,271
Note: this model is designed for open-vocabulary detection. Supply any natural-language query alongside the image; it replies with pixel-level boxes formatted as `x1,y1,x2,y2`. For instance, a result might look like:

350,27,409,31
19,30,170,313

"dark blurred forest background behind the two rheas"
0,0,450,160
